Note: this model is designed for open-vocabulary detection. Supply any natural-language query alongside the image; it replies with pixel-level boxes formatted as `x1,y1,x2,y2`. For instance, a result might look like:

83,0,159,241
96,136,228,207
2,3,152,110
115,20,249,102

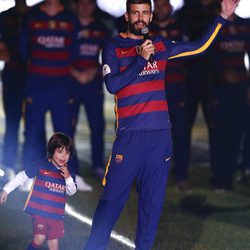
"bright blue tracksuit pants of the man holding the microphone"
85,130,172,250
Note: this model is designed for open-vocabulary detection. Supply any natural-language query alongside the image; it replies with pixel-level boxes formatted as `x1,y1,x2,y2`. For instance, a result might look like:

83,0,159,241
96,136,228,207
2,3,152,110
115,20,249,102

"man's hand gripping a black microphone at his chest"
141,27,155,63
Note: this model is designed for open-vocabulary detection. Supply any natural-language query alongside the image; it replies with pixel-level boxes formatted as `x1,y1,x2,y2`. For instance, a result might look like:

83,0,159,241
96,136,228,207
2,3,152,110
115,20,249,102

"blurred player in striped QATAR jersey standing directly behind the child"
20,0,92,191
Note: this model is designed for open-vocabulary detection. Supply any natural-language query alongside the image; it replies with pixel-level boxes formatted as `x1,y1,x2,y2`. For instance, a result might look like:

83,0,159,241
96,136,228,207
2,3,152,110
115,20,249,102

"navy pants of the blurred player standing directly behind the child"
23,77,73,168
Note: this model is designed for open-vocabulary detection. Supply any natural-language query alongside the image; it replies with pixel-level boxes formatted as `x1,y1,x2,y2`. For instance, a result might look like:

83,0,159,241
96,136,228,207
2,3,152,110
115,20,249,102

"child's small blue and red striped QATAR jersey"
24,159,75,220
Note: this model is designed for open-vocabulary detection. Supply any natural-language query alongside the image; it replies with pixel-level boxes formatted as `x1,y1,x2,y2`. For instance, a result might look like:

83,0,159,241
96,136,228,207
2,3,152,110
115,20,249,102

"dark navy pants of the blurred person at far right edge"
210,84,247,189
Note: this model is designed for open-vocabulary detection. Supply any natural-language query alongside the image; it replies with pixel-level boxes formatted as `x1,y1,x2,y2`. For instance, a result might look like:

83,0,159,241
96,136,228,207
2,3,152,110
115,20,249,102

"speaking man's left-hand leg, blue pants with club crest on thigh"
85,133,144,250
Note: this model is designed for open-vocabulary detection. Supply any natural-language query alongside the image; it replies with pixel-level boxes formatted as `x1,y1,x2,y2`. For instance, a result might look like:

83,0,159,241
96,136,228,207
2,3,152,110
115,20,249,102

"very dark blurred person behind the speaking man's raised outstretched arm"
176,0,220,165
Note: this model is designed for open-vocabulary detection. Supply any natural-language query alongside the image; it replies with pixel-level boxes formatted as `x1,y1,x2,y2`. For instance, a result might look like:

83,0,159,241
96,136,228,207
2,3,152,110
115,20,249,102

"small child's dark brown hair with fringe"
47,132,74,158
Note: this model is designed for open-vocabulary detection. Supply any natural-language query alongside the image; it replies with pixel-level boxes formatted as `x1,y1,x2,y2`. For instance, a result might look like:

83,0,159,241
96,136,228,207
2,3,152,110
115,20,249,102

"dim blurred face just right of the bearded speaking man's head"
154,0,172,21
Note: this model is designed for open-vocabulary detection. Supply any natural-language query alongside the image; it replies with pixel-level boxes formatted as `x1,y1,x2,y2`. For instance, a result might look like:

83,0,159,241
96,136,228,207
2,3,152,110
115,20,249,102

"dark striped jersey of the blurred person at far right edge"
209,16,250,84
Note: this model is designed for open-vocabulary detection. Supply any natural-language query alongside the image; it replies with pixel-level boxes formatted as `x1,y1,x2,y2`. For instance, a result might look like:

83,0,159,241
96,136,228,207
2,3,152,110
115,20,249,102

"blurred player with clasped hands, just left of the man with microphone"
71,0,110,179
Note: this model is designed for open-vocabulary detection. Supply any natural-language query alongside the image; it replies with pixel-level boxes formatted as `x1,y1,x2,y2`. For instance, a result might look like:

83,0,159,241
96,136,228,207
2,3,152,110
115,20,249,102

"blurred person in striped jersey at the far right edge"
209,9,250,189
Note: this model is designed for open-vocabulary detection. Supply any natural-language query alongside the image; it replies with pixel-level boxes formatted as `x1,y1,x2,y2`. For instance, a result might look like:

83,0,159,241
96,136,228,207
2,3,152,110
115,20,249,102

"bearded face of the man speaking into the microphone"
125,4,152,36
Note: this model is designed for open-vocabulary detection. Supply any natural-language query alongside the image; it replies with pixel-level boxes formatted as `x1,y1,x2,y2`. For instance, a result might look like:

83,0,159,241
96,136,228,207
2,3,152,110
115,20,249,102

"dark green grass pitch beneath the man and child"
0,166,250,250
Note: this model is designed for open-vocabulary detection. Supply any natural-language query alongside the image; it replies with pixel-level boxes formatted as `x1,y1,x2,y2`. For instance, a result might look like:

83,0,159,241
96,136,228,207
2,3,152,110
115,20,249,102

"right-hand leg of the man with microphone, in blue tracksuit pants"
136,130,172,250
